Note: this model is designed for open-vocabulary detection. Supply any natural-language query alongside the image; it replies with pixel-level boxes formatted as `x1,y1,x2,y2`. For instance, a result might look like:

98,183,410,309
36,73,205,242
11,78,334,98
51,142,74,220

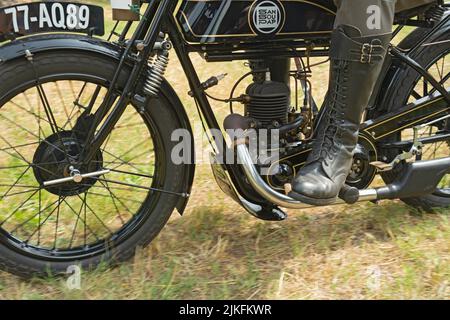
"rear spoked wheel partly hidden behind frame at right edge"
382,30,450,210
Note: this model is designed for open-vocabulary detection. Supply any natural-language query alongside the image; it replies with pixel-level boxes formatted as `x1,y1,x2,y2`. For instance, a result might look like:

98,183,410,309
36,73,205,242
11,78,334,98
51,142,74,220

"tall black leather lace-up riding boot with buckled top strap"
289,25,391,206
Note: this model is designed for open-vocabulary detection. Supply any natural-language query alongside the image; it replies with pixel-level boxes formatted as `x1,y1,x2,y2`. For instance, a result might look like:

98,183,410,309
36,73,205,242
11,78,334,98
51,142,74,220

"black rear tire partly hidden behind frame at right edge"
381,25,450,212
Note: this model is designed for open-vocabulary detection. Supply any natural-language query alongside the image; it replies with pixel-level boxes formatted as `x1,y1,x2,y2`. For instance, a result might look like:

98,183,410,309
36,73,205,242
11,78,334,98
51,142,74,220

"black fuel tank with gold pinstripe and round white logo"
177,0,336,44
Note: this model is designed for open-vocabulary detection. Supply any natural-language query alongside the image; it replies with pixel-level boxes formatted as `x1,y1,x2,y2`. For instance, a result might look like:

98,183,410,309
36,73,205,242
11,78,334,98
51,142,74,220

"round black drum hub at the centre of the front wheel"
33,131,103,196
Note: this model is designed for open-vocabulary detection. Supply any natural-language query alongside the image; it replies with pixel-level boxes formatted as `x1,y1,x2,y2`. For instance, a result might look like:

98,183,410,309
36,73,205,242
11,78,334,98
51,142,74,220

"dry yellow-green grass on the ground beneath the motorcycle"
0,0,450,300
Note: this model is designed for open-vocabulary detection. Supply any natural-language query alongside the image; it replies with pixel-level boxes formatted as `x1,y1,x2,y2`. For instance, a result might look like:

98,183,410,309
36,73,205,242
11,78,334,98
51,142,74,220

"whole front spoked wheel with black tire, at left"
0,53,182,276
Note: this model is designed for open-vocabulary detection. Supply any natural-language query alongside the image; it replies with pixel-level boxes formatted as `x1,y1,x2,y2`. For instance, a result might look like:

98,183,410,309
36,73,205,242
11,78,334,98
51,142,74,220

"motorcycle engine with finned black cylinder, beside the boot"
217,58,318,191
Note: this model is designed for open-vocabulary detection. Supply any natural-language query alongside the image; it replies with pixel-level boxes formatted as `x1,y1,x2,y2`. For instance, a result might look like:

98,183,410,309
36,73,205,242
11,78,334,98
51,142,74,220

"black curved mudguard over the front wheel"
0,34,195,214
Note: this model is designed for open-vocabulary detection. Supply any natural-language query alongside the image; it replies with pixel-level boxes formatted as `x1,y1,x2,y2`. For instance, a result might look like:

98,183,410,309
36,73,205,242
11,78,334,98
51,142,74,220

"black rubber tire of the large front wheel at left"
0,51,185,277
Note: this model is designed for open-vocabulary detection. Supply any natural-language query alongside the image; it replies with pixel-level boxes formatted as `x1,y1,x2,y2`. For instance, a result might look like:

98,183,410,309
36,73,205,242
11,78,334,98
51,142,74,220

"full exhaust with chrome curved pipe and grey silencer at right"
236,139,450,209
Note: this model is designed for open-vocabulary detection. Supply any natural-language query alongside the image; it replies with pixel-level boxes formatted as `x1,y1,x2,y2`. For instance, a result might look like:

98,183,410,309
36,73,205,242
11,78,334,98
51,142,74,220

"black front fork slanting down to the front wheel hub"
77,0,172,163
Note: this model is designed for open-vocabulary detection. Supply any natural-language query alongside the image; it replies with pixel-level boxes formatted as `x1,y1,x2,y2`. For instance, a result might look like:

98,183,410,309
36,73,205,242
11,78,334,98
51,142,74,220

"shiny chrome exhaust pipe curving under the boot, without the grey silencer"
236,143,379,209
